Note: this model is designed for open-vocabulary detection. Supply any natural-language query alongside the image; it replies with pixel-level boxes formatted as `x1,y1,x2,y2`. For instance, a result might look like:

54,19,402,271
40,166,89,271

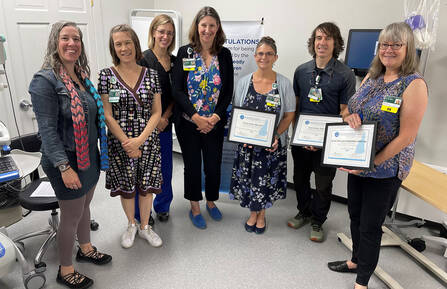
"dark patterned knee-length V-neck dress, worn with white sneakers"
98,67,162,198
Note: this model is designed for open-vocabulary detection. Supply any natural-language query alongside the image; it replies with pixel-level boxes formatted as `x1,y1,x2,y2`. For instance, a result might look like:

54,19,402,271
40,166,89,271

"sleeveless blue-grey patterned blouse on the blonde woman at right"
348,73,422,180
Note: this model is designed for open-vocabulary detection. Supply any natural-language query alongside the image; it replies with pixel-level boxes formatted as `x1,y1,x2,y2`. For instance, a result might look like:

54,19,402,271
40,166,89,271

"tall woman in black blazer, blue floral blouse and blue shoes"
173,7,234,229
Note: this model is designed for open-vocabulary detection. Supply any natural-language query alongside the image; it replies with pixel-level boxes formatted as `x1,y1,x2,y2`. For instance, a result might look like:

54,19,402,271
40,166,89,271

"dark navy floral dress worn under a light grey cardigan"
230,79,287,211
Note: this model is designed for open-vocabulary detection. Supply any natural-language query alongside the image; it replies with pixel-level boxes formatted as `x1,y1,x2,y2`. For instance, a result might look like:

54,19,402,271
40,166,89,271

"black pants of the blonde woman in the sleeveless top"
348,174,402,286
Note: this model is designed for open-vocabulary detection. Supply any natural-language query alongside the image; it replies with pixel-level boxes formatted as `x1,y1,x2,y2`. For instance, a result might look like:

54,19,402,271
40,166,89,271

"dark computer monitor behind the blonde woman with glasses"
345,29,382,76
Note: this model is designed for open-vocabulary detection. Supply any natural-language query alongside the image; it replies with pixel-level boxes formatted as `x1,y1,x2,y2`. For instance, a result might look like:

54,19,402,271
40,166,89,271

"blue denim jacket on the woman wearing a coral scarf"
29,69,76,167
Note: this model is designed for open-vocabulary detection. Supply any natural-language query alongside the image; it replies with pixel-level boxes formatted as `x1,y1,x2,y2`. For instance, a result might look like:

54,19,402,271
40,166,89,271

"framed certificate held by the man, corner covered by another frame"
290,113,343,148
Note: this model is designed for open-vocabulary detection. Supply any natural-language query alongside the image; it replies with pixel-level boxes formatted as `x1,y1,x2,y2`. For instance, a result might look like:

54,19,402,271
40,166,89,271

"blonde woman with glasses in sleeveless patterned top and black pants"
328,23,428,289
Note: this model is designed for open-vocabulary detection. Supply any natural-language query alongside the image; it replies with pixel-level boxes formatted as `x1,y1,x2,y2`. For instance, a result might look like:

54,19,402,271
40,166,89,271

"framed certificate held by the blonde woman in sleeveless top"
321,122,377,169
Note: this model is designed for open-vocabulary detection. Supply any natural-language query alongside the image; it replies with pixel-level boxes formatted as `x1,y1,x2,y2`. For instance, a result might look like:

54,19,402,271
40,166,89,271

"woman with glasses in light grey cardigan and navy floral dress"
230,36,295,234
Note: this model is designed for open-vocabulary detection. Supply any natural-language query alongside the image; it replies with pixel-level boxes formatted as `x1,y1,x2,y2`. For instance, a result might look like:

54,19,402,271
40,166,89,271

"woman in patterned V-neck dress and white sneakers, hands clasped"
98,24,162,248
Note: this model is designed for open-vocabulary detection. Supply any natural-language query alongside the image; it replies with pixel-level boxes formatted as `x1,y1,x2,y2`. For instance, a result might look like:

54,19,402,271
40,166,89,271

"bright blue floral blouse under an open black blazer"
187,52,222,116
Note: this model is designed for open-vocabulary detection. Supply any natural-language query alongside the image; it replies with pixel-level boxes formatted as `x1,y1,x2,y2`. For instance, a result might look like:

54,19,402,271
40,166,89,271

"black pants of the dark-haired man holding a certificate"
292,146,336,225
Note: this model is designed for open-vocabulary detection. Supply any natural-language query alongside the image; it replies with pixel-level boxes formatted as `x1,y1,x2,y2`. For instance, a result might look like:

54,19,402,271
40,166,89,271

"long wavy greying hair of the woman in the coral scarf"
42,21,90,76
